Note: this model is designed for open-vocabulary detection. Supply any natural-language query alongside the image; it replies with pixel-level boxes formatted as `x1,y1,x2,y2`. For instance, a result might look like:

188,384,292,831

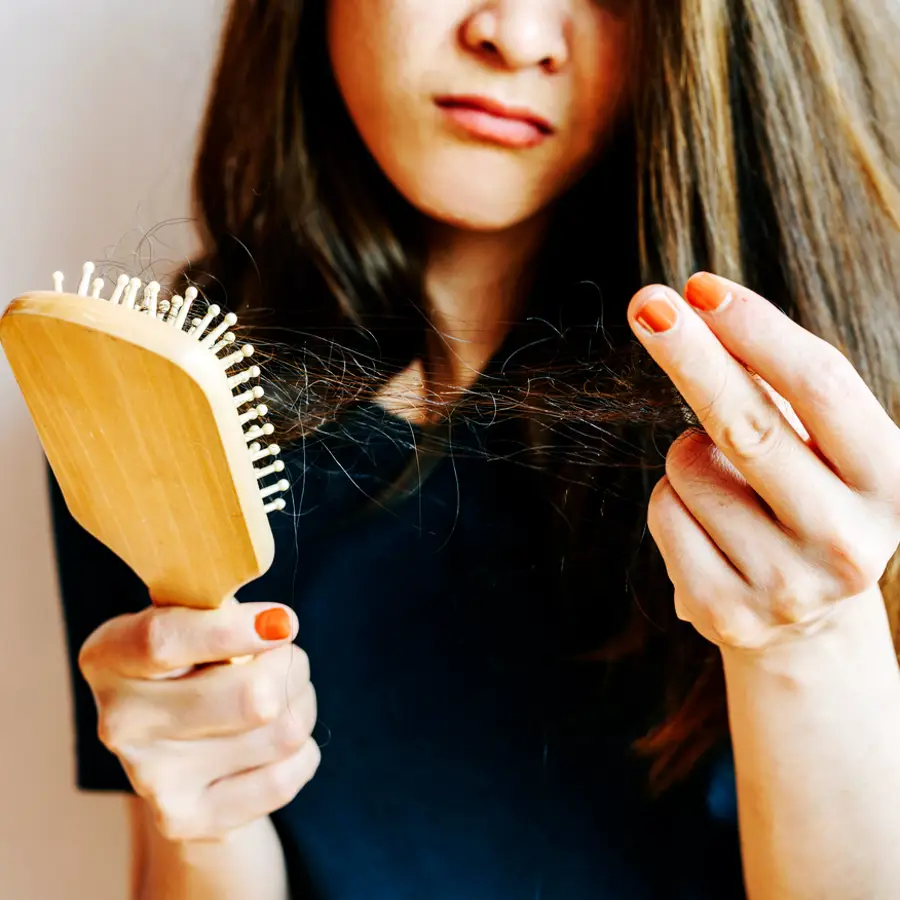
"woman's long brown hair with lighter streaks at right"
185,0,900,785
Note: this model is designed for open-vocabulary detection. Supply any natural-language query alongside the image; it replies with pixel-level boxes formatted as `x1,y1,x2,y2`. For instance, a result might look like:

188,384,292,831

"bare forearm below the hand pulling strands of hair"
723,591,900,900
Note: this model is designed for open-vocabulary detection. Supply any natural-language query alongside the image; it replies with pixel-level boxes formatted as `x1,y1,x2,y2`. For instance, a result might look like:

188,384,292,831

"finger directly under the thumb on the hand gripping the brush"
101,644,310,746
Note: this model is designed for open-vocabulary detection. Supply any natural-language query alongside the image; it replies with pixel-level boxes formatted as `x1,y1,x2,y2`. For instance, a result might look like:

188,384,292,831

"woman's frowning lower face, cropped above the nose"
328,0,631,230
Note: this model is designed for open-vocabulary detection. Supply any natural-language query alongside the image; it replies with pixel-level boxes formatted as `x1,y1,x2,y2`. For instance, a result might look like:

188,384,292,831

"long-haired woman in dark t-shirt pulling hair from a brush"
54,0,900,900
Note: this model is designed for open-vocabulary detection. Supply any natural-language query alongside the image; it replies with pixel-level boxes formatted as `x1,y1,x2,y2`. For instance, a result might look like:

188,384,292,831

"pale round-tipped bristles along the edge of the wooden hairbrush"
53,262,290,512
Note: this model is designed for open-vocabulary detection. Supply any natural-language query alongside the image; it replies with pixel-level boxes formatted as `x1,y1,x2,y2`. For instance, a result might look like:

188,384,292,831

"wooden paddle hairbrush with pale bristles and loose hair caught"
0,263,289,609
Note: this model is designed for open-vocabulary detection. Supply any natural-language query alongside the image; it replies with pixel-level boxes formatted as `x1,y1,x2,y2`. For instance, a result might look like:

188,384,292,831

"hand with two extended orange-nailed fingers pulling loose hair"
628,272,900,650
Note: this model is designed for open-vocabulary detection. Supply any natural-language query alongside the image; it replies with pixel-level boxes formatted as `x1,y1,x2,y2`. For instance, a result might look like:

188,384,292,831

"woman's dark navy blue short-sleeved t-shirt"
51,404,744,900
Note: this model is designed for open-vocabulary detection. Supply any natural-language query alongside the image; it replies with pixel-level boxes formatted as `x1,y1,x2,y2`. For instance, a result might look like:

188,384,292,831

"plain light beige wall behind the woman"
0,0,225,900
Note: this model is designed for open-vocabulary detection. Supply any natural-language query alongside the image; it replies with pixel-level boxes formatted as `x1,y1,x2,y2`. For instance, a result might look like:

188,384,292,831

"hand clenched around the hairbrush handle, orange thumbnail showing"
79,603,320,841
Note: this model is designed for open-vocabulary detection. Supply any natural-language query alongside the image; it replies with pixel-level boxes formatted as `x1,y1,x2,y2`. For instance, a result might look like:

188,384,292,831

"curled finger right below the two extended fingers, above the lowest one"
666,432,837,624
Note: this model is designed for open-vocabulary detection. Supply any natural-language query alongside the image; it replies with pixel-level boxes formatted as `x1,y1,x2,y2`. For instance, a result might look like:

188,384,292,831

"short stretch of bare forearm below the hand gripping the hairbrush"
132,799,288,900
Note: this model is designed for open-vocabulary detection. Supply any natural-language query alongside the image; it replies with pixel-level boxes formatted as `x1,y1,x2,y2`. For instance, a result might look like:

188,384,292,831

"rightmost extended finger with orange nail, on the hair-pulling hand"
685,272,900,497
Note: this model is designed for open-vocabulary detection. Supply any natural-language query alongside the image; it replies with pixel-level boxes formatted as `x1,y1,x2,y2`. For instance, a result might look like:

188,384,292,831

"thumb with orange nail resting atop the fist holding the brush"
79,603,298,678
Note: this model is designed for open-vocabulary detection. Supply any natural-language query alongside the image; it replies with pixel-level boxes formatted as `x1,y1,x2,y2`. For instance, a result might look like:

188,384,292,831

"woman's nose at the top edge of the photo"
461,0,571,72
